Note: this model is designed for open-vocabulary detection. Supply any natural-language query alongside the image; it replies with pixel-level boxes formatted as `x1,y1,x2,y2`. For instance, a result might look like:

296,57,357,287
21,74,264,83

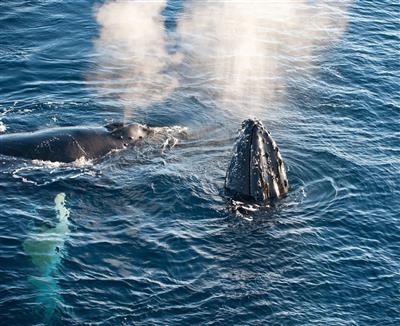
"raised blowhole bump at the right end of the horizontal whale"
106,123,154,144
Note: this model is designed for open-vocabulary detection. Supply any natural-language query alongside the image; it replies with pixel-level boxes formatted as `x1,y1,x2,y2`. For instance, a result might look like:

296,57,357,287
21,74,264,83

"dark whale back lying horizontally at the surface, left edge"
0,123,152,163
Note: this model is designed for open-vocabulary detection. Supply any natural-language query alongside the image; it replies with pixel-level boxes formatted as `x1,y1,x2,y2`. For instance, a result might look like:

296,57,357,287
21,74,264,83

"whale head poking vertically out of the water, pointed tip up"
225,119,289,204
